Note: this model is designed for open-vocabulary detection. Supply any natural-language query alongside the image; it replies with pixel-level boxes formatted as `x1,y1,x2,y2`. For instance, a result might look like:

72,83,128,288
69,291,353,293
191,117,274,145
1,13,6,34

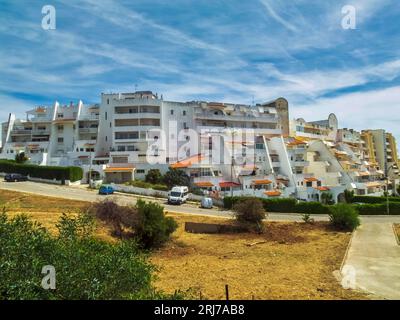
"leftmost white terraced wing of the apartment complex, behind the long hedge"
1,101,99,166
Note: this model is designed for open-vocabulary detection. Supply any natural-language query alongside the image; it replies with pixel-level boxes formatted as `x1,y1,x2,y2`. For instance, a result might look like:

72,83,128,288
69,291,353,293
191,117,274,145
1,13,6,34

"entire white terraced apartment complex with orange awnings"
1,91,398,201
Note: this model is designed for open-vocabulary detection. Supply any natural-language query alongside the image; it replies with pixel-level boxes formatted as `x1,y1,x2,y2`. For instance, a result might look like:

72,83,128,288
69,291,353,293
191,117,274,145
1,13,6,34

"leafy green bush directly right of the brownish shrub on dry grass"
134,199,178,249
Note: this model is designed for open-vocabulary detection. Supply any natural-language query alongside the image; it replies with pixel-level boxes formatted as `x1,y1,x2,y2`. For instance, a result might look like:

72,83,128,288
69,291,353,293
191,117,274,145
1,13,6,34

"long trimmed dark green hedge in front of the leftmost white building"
0,160,83,182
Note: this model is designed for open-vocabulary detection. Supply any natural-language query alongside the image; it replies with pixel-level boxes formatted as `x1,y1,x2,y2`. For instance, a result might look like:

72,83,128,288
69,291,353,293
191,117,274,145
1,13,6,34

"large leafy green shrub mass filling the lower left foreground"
0,213,168,300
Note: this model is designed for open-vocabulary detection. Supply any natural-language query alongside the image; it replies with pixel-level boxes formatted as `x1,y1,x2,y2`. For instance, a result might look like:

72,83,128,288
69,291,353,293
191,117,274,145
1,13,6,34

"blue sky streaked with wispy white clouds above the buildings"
0,0,400,140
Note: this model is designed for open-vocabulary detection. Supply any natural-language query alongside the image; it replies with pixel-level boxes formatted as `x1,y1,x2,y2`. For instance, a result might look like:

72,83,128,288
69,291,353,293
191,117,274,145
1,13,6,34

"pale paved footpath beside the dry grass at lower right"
345,222,400,299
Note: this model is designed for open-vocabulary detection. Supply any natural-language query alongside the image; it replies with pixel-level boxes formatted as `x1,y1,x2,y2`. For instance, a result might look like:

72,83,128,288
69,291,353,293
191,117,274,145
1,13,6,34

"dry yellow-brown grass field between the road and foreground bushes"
0,190,367,299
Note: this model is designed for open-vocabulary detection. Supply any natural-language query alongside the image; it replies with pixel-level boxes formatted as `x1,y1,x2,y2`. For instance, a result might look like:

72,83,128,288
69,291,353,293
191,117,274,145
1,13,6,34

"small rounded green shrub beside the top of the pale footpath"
329,203,360,231
